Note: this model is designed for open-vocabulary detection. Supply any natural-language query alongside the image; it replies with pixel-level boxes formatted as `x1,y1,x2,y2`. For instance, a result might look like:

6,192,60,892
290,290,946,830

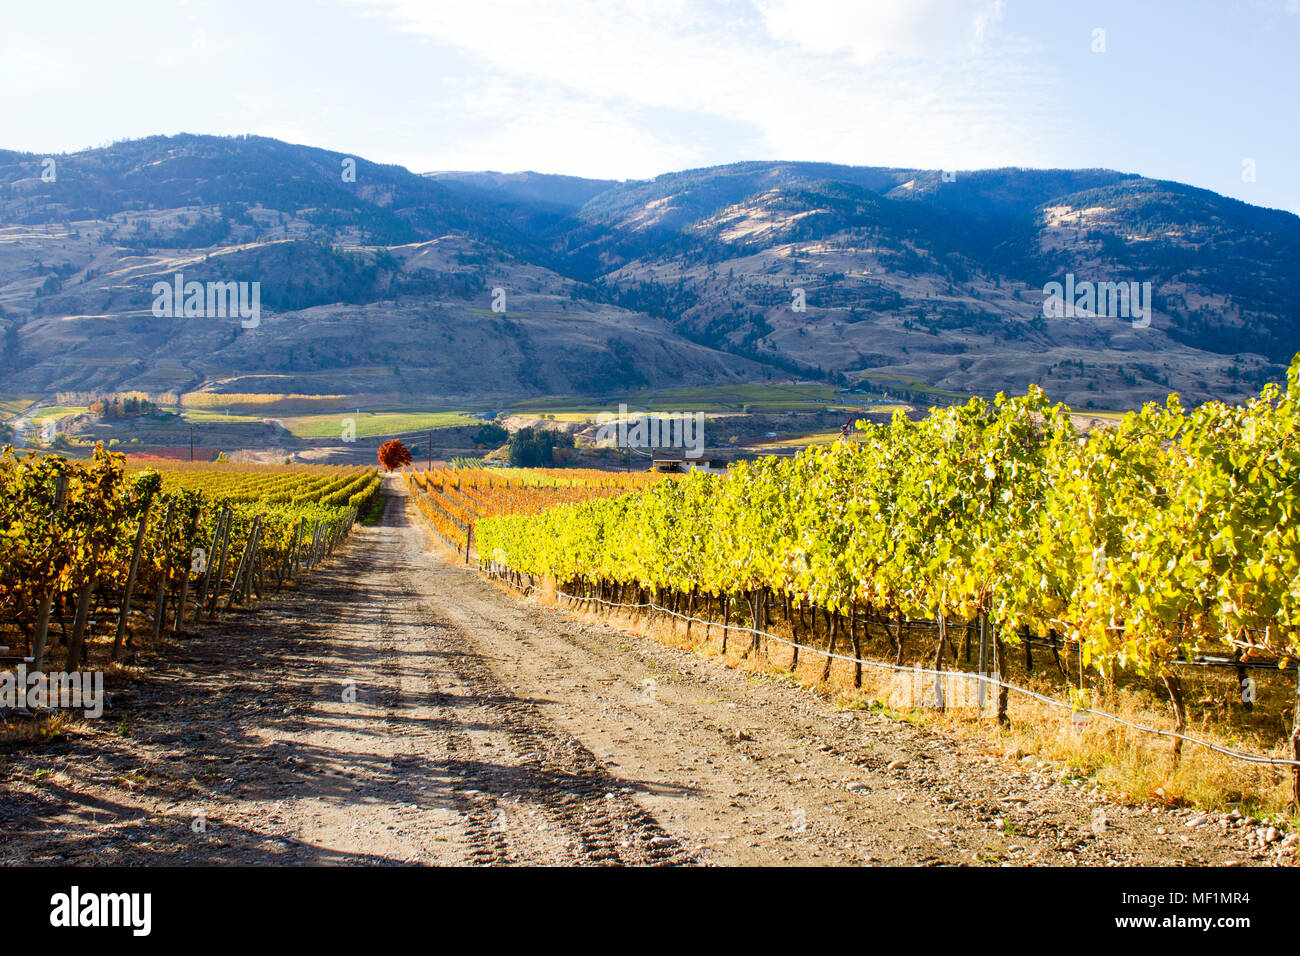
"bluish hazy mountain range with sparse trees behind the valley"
0,134,1300,408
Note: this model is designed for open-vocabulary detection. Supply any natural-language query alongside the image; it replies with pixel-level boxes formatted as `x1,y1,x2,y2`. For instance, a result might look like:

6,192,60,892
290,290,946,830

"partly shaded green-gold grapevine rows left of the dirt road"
0,447,381,670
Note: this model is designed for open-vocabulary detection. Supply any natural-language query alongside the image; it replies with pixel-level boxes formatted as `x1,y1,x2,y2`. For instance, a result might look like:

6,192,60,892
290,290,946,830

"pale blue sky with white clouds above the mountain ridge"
0,0,1300,215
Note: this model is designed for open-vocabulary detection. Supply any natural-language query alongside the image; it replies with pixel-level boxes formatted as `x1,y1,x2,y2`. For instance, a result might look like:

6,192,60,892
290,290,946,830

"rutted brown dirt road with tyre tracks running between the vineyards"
0,481,1279,865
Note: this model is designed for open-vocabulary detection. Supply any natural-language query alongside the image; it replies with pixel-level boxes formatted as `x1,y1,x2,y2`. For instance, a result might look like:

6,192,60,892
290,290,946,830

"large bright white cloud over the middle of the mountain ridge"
352,0,1063,176
